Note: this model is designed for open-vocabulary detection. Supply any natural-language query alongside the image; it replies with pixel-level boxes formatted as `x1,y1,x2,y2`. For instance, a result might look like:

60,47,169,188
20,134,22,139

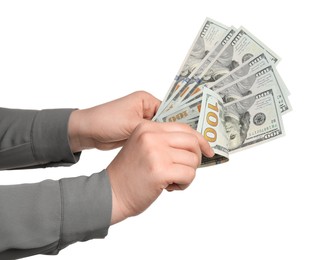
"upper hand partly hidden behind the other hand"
68,91,160,152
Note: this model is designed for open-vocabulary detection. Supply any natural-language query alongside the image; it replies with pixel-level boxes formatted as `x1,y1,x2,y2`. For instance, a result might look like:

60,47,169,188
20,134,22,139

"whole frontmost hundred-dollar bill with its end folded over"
197,88,284,166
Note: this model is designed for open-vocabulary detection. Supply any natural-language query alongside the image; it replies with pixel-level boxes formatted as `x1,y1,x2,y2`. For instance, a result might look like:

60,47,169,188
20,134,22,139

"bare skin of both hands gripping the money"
68,92,214,224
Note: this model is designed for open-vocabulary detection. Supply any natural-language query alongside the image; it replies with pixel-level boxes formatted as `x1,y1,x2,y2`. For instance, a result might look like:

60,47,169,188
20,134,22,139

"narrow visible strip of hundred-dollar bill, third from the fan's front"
178,53,270,106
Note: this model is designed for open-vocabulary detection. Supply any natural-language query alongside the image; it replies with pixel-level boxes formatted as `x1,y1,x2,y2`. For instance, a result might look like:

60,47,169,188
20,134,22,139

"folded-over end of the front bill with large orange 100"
197,88,229,166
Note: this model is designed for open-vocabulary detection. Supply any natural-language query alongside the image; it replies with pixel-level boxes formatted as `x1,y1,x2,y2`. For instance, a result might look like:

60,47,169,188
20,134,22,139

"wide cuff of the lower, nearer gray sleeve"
59,170,112,250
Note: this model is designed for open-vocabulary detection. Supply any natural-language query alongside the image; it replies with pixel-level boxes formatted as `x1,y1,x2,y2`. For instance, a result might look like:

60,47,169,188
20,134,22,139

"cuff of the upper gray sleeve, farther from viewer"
31,109,80,166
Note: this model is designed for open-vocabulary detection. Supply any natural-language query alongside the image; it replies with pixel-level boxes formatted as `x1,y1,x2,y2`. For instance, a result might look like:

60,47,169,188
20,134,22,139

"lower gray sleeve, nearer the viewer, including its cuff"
0,171,112,259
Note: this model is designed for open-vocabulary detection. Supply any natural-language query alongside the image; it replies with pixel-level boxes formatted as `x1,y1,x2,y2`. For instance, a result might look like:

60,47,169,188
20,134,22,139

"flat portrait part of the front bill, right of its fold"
224,89,284,153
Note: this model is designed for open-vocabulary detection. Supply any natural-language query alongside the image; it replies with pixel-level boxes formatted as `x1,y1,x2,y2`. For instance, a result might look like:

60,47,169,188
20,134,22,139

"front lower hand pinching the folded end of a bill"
107,122,214,224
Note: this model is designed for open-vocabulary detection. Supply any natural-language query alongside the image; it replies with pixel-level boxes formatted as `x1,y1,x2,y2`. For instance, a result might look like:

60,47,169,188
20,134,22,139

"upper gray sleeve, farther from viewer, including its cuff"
0,108,80,170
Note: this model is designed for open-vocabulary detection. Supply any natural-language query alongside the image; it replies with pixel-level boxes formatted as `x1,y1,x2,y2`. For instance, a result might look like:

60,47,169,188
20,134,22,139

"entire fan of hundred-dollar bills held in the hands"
153,18,291,166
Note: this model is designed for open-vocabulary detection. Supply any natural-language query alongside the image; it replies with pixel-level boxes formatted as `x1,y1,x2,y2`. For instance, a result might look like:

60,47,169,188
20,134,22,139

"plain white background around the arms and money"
0,0,318,260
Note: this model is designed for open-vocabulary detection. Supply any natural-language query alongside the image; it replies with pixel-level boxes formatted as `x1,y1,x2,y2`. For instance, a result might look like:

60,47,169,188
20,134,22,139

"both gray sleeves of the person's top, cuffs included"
0,108,112,260
